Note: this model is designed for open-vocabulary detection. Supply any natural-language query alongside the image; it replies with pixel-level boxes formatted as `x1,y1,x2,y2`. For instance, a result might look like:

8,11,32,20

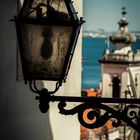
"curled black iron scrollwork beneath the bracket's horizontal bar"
58,101,140,132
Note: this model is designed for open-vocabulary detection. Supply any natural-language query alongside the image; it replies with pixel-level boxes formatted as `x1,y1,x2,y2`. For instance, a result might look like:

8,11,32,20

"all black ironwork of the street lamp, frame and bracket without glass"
14,0,140,133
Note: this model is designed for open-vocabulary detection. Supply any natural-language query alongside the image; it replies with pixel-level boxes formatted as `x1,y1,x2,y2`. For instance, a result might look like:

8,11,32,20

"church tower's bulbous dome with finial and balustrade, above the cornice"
100,8,140,65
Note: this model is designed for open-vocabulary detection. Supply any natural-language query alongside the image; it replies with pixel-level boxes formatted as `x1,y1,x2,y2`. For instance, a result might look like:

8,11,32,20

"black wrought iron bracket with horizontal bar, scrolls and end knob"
30,85,140,133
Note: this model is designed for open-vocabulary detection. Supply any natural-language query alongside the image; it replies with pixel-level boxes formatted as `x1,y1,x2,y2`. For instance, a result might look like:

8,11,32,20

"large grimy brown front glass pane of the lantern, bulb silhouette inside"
20,24,73,80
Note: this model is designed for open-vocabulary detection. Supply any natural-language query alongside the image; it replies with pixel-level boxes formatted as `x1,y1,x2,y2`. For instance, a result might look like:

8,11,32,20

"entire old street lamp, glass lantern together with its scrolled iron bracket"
14,0,140,132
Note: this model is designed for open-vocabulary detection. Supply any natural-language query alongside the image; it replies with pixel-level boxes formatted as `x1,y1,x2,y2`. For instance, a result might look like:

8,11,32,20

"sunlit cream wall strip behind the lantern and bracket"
45,0,82,140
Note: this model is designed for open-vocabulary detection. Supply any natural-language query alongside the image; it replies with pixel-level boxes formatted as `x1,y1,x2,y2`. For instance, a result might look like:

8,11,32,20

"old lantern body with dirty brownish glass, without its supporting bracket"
15,0,83,83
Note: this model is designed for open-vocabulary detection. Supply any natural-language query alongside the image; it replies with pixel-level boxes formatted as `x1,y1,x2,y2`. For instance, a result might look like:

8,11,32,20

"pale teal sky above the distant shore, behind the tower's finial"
83,0,140,31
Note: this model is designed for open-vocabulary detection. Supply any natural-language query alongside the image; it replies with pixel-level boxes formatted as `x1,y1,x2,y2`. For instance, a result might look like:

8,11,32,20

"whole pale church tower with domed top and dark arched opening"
99,7,140,98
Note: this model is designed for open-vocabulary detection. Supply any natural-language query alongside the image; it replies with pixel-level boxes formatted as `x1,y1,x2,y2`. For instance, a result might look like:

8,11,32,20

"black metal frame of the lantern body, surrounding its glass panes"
14,0,84,84
